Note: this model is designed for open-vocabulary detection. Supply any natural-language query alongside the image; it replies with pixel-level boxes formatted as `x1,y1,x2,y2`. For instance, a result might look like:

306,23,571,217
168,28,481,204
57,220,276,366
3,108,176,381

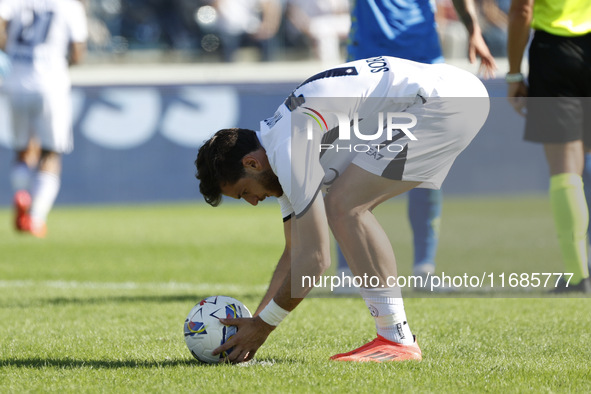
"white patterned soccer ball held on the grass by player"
184,296,252,364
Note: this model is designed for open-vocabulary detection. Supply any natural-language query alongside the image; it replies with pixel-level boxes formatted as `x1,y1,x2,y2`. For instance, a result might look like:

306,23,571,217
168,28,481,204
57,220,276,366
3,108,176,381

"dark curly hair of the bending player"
195,128,261,207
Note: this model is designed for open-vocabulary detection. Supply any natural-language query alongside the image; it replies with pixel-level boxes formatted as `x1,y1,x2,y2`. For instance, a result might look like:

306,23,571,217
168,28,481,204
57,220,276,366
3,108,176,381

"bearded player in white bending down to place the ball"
195,56,489,362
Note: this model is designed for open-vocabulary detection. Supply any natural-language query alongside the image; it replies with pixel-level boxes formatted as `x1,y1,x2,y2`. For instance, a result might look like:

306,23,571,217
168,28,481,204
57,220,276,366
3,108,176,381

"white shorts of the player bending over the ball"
352,64,490,189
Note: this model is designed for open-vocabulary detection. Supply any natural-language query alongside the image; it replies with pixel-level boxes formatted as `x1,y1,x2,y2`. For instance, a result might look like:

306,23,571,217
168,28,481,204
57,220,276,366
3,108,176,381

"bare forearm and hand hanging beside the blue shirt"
453,0,497,78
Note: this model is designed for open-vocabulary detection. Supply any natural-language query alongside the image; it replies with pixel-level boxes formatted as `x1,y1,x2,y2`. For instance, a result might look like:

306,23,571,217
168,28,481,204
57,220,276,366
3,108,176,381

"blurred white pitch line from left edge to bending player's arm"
0,280,266,294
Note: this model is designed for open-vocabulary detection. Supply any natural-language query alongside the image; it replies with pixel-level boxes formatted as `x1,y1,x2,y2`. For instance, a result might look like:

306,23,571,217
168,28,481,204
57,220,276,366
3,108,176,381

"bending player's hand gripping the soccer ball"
213,316,275,363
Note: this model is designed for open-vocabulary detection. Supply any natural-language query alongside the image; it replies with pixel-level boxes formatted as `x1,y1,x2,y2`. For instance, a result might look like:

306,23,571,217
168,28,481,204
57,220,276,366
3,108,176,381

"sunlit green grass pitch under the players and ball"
0,197,591,393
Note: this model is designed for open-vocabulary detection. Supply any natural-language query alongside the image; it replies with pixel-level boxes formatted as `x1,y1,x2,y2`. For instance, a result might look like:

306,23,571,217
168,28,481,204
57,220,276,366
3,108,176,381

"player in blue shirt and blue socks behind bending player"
337,0,496,290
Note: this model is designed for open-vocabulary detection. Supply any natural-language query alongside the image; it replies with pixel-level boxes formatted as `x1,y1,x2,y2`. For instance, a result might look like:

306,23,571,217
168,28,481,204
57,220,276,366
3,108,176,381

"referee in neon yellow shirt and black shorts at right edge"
506,0,591,293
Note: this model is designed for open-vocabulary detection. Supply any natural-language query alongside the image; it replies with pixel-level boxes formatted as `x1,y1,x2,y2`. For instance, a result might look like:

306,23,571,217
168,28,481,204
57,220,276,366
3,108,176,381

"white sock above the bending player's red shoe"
360,288,414,345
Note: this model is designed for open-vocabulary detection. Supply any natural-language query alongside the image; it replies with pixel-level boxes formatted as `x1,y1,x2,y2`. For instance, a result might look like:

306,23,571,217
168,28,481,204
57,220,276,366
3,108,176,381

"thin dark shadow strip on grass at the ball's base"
0,357,297,369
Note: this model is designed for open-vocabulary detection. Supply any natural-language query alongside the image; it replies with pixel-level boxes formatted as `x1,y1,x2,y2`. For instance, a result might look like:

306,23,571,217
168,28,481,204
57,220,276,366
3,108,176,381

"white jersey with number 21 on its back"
0,0,88,92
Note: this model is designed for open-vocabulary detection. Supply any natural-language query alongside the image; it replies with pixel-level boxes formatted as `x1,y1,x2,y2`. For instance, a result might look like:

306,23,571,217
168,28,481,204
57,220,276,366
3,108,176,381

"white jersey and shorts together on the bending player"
258,56,488,218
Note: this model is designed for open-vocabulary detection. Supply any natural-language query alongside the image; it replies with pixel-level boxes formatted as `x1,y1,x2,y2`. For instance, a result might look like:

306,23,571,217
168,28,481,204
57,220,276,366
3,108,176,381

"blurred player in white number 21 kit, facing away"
0,0,88,238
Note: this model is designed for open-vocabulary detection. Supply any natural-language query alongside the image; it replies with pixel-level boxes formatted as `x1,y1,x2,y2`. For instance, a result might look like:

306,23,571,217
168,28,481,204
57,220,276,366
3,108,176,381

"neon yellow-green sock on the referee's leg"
550,173,589,285
